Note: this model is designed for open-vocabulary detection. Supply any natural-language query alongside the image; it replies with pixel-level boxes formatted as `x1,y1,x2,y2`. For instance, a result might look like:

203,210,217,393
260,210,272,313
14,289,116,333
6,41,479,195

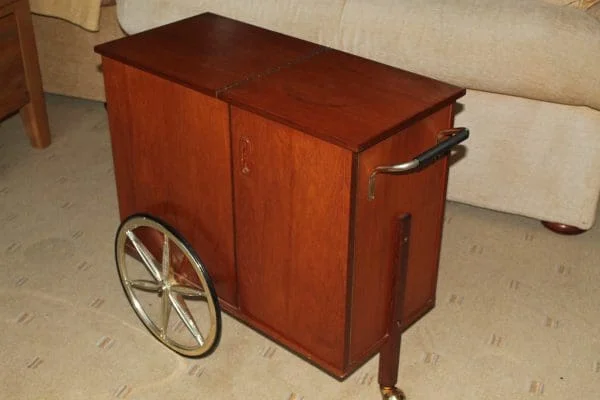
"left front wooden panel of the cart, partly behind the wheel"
102,57,237,305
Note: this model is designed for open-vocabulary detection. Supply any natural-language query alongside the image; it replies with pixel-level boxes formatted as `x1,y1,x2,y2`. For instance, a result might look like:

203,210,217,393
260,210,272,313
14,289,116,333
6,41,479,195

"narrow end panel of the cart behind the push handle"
350,106,452,368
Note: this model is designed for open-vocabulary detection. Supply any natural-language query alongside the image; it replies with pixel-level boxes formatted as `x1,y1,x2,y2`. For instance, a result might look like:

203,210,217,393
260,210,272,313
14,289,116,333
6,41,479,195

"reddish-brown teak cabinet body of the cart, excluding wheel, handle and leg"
96,13,464,378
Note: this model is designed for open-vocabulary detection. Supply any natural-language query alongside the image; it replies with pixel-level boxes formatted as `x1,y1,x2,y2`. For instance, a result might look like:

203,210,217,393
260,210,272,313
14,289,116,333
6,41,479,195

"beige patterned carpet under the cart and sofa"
0,96,600,400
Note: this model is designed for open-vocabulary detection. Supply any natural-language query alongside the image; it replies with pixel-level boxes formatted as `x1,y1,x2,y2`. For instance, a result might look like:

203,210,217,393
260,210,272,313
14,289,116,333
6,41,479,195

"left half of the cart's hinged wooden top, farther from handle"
94,13,322,96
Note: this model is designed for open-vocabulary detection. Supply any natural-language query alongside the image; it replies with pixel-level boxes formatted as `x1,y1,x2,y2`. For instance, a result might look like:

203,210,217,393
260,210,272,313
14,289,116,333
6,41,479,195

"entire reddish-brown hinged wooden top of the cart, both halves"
96,13,465,151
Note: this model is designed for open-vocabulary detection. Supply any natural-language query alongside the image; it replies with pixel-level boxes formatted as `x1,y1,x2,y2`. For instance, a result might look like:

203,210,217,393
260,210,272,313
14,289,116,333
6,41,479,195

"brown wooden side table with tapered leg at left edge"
0,0,50,148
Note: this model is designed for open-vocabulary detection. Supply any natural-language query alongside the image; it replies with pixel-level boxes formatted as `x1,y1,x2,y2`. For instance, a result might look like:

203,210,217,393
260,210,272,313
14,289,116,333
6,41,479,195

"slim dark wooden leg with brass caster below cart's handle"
379,214,411,400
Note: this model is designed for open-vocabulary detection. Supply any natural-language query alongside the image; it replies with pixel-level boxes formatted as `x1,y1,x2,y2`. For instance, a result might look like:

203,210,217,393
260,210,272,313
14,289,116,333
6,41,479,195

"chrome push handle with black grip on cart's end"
369,128,469,200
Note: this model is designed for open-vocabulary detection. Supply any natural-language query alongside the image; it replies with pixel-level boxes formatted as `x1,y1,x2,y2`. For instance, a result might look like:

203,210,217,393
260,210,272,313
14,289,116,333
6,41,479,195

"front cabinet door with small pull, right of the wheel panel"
231,108,352,374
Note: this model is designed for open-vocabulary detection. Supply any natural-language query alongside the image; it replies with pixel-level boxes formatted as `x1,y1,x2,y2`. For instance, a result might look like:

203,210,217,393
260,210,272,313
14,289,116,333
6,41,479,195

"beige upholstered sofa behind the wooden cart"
36,0,600,230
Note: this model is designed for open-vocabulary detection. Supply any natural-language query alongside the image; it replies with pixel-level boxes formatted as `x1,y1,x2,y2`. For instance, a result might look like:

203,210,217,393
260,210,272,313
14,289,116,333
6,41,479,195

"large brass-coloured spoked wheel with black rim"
115,214,221,357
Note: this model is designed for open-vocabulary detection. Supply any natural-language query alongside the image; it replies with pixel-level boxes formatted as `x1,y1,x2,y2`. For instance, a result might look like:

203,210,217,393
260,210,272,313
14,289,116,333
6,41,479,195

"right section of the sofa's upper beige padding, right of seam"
340,0,600,109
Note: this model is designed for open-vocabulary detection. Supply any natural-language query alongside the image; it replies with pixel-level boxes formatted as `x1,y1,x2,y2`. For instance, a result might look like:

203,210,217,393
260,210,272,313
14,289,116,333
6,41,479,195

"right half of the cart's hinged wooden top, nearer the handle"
222,50,464,151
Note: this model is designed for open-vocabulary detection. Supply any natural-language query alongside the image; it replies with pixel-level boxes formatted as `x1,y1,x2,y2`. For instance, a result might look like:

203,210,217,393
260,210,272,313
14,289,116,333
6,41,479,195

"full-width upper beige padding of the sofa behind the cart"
118,0,600,109
